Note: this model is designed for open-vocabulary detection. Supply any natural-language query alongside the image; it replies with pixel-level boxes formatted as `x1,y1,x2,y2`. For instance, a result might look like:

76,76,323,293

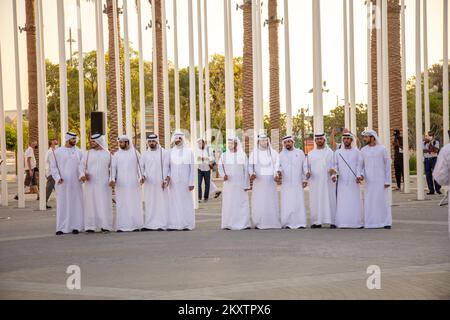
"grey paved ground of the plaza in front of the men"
0,180,450,299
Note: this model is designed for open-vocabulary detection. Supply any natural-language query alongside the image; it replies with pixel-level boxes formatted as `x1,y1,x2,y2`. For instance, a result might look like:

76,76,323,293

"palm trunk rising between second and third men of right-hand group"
268,0,280,151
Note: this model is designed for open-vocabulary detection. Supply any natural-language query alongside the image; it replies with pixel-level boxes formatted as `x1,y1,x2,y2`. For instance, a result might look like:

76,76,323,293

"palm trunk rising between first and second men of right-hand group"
242,0,254,153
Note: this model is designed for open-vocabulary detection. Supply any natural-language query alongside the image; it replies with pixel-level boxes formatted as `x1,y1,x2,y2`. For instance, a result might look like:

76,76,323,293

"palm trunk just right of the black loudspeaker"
106,0,125,152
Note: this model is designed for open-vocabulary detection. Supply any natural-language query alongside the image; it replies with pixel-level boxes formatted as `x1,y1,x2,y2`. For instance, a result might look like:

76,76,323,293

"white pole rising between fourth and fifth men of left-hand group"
161,0,170,148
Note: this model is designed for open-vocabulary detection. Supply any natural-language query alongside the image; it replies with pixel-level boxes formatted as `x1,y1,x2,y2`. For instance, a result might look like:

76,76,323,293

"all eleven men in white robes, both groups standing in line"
49,130,392,235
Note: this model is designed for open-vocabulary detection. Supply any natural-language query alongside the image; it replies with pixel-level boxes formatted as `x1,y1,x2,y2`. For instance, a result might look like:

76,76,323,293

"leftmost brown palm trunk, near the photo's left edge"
25,0,39,163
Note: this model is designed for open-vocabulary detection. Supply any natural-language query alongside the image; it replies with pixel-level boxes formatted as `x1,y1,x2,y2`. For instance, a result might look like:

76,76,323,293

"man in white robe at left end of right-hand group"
219,137,251,230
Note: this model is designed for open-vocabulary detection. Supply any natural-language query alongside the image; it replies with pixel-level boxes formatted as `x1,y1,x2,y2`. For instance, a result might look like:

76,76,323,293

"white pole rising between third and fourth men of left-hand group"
136,0,147,153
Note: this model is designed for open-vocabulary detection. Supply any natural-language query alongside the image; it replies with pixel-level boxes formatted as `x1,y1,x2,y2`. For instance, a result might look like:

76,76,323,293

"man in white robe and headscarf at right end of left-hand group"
167,132,195,230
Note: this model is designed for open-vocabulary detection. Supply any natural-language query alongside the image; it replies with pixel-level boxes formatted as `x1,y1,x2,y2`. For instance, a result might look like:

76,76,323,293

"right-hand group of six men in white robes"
219,130,392,230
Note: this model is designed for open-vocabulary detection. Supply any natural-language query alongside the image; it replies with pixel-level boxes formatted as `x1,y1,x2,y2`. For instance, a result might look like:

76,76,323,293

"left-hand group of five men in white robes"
49,132,195,235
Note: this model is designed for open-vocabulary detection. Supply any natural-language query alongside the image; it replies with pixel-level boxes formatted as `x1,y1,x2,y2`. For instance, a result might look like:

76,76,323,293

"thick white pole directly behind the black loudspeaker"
95,0,108,136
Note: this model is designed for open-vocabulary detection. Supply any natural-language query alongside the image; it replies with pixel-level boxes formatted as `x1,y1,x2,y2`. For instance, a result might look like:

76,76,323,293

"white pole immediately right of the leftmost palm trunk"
35,0,47,211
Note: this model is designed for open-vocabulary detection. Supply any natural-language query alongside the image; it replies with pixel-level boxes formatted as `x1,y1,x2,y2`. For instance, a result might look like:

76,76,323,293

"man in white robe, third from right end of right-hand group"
306,133,336,229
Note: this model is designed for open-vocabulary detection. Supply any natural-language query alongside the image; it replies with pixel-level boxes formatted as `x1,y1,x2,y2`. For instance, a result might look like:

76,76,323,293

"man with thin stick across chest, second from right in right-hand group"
332,133,363,229
